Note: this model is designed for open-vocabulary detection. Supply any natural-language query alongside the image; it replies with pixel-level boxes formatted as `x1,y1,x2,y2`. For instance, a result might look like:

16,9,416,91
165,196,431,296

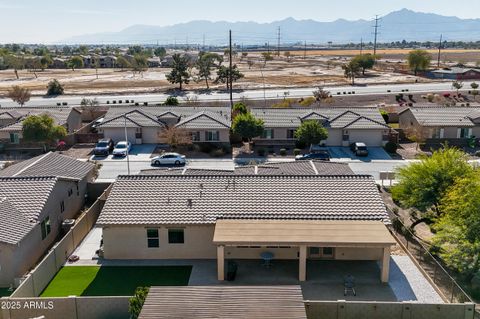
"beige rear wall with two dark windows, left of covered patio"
103,225,217,259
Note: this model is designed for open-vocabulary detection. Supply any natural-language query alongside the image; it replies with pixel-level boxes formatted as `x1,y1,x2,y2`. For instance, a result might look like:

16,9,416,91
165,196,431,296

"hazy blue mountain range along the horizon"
59,9,480,46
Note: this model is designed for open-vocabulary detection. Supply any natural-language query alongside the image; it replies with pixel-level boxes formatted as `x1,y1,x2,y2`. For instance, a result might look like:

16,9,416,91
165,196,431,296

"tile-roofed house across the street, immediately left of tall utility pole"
97,106,230,144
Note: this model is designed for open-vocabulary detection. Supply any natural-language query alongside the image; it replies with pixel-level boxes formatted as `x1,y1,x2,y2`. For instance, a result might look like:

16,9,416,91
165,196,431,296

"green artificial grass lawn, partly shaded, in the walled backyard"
40,266,192,297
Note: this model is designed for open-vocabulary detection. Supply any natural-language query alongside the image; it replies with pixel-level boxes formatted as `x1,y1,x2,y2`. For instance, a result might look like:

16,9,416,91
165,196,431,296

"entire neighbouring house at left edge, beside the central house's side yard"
0,153,94,287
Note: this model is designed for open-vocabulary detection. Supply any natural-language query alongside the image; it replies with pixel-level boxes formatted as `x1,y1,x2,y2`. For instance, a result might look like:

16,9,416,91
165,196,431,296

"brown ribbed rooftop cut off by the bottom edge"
139,286,307,319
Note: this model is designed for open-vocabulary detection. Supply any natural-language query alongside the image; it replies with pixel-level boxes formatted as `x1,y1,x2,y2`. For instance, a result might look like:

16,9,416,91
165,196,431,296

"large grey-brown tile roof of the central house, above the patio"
98,175,388,226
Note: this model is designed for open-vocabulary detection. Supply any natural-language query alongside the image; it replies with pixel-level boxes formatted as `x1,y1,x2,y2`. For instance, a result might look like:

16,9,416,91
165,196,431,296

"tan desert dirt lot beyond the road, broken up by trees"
0,49,480,95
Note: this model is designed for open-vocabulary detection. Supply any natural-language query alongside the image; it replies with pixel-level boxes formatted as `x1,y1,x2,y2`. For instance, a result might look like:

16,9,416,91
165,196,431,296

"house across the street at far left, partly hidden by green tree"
0,107,82,144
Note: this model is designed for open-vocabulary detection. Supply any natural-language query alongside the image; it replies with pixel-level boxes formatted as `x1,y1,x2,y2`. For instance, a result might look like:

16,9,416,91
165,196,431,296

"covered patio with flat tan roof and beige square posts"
213,219,396,283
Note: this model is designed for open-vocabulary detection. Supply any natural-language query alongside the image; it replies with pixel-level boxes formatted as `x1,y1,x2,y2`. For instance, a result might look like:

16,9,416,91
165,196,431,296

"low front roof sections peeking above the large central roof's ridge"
140,160,355,175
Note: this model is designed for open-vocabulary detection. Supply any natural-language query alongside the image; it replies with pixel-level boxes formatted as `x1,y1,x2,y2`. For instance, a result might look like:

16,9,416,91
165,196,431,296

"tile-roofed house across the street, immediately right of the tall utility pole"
251,107,392,146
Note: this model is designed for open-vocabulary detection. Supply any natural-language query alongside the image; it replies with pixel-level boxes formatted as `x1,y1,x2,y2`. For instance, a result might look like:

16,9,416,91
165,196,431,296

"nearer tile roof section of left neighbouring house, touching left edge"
0,176,61,244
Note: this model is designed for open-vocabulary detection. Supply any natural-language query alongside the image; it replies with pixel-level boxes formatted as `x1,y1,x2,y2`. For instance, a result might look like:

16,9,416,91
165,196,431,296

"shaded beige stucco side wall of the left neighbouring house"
0,180,87,287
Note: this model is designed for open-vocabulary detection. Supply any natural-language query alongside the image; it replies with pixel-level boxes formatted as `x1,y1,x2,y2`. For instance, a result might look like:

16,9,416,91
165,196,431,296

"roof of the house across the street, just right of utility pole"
252,107,388,129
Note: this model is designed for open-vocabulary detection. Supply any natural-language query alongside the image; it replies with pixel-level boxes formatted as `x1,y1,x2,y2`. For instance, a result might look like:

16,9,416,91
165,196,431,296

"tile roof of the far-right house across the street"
402,107,480,127
